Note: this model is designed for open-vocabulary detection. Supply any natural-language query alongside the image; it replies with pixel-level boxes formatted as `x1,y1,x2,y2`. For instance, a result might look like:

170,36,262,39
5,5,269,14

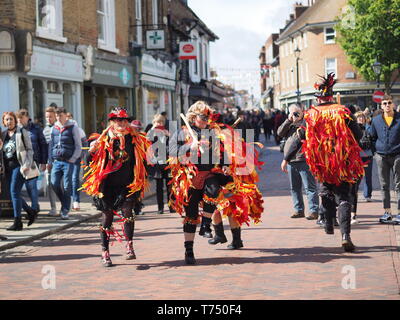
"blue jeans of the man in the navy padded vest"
51,160,74,212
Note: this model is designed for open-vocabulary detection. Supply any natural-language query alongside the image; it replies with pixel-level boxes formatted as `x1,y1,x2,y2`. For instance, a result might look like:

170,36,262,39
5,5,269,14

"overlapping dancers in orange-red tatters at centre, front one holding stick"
169,101,263,264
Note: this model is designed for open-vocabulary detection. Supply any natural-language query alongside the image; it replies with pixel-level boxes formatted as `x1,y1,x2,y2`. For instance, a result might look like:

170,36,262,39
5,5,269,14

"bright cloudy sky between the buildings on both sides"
188,0,300,98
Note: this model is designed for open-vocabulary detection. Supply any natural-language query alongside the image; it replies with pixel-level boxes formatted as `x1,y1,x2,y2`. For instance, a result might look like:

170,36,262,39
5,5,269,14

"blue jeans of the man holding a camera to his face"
288,161,319,213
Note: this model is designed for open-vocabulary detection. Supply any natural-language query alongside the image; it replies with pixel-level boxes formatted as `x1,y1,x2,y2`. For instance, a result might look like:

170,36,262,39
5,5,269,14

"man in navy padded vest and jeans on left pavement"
48,108,82,220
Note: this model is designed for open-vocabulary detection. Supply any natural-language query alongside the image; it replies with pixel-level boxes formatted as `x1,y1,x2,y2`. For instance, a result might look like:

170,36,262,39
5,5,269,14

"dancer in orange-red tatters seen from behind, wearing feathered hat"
286,73,364,252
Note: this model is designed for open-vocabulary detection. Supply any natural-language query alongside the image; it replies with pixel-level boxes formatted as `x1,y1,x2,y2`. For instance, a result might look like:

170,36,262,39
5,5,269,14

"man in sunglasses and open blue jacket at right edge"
370,95,400,224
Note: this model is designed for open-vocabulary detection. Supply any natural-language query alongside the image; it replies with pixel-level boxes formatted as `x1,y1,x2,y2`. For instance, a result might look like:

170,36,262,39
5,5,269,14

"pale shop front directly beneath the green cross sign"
140,54,178,126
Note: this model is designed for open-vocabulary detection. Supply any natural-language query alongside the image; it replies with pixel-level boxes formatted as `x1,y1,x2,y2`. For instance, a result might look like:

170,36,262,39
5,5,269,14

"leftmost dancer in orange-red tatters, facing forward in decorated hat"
82,107,150,267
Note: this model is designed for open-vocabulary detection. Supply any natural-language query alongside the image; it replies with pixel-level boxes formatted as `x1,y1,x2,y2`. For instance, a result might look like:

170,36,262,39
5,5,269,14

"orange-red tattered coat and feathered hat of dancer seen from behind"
302,74,364,185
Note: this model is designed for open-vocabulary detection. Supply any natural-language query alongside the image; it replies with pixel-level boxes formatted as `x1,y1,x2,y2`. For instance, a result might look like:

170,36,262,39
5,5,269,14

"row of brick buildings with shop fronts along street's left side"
0,0,217,132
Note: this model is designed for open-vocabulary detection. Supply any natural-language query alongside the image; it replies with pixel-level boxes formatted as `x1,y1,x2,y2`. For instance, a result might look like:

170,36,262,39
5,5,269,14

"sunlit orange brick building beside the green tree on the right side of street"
260,0,400,108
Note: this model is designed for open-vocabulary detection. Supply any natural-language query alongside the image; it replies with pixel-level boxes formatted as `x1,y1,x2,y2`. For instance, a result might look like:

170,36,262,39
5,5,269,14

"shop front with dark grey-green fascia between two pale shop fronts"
84,59,134,132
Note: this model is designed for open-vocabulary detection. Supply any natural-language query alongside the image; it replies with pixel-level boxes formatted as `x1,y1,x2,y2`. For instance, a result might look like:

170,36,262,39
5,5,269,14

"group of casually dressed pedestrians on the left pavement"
0,106,86,231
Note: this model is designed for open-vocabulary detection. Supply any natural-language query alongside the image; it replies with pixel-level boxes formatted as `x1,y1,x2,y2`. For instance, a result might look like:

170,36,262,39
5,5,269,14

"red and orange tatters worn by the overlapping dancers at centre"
168,119,263,225
